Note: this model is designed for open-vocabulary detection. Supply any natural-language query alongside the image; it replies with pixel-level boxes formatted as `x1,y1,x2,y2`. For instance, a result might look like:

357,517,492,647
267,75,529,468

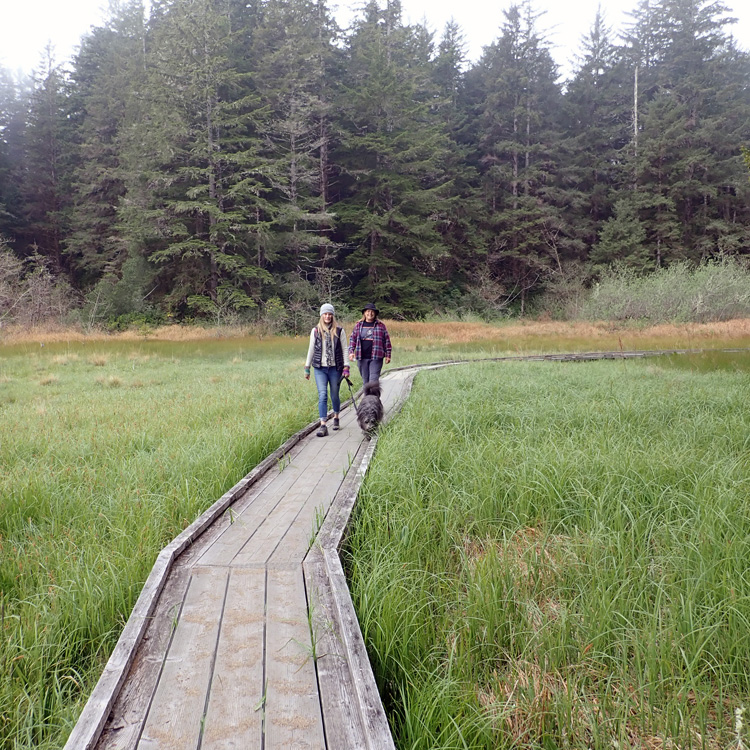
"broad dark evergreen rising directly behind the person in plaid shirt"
335,0,450,316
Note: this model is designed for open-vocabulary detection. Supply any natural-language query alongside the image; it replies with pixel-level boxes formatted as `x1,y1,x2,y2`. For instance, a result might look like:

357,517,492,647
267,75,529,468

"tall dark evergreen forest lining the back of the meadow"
0,0,750,328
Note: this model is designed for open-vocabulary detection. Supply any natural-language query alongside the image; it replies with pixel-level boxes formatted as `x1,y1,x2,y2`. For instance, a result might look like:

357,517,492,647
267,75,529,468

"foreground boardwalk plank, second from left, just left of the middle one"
138,568,228,750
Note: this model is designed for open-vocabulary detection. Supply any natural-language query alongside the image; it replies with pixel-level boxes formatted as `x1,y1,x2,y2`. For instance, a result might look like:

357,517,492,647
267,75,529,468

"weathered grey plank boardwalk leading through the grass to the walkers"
66,371,413,750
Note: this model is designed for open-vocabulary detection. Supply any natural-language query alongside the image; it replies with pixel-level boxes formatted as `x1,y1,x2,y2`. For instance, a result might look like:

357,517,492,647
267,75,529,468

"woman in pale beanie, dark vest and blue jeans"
305,303,349,437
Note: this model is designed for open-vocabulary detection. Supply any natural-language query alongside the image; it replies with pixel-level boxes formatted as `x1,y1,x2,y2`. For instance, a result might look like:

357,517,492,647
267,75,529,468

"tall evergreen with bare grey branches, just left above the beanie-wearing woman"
251,0,338,288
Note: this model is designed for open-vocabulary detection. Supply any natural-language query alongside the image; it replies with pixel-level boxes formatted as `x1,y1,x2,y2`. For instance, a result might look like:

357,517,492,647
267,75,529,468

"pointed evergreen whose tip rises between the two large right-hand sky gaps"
478,0,577,314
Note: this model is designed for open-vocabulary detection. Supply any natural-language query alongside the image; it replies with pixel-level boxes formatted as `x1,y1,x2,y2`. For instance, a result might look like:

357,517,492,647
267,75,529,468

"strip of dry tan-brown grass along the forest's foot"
0,318,750,348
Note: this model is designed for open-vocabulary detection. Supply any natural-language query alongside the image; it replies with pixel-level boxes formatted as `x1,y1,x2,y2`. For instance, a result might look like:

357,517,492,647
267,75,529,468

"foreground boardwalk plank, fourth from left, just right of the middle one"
264,566,326,750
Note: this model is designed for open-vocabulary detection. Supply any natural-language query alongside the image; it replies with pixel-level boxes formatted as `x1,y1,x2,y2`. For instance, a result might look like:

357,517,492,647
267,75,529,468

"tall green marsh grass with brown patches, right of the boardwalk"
346,354,750,750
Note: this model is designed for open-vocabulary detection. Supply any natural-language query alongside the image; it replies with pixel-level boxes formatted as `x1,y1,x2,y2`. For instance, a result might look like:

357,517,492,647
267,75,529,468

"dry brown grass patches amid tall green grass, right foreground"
463,527,725,750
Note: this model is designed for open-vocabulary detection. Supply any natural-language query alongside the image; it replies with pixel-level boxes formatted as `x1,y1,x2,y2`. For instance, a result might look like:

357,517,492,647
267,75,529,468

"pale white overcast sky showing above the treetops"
0,0,750,81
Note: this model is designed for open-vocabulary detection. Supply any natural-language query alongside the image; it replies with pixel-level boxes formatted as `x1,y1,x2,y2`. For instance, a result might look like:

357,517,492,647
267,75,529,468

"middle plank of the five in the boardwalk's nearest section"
201,569,266,750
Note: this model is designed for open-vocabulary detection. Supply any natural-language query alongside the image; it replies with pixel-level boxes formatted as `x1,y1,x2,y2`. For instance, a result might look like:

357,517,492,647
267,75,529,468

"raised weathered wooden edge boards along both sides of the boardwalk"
64,348,748,750
